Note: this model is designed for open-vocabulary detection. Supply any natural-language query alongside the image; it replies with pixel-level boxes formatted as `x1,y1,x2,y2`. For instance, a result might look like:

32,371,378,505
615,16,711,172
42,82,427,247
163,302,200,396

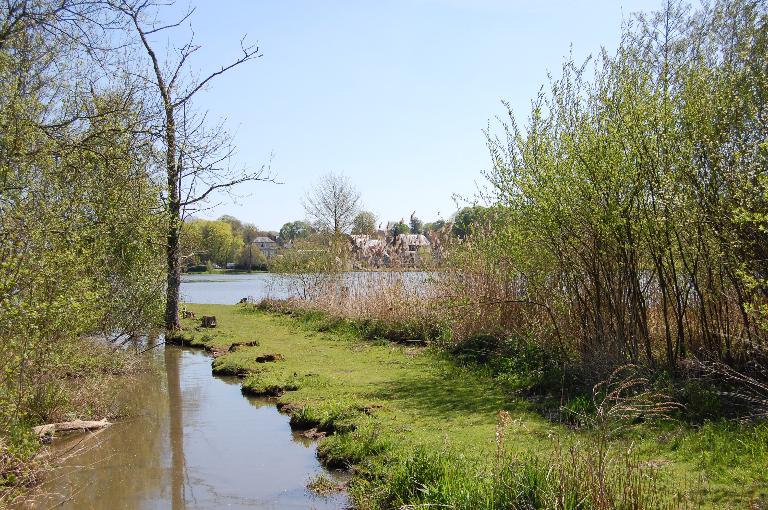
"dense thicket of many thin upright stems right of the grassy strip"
462,0,768,384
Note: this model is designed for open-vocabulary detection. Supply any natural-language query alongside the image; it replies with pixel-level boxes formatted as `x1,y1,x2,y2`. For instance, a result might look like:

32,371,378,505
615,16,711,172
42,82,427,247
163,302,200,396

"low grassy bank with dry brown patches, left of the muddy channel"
0,338,151,508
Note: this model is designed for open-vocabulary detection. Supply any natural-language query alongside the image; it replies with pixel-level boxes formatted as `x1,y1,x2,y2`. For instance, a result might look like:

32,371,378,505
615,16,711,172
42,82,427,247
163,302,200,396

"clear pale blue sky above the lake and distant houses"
168,0,660,230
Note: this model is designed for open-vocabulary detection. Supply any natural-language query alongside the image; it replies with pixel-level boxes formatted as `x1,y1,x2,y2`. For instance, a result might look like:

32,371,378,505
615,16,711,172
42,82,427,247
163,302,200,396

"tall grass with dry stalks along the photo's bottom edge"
351,445,693,510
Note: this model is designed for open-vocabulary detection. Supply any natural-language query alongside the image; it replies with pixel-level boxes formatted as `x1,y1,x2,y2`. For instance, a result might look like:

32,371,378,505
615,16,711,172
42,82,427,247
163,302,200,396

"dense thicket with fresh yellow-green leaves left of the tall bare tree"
0,0,165,450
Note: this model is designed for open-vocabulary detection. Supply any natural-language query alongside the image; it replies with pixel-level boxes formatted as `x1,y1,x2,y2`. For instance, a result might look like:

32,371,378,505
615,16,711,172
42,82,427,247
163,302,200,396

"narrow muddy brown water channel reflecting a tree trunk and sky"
26,347,346,510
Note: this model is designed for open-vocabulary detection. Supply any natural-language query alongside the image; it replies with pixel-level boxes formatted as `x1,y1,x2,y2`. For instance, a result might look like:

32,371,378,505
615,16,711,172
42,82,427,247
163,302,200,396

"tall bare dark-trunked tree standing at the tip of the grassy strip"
107,0,271,332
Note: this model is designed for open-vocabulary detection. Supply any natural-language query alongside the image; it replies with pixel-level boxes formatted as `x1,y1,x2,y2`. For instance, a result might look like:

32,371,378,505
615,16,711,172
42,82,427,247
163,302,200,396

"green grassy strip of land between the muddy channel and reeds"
185,305,768,509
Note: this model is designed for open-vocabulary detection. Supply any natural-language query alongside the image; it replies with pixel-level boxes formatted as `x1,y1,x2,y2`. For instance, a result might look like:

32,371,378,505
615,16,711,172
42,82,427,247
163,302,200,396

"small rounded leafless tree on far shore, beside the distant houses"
304,173,360,236
